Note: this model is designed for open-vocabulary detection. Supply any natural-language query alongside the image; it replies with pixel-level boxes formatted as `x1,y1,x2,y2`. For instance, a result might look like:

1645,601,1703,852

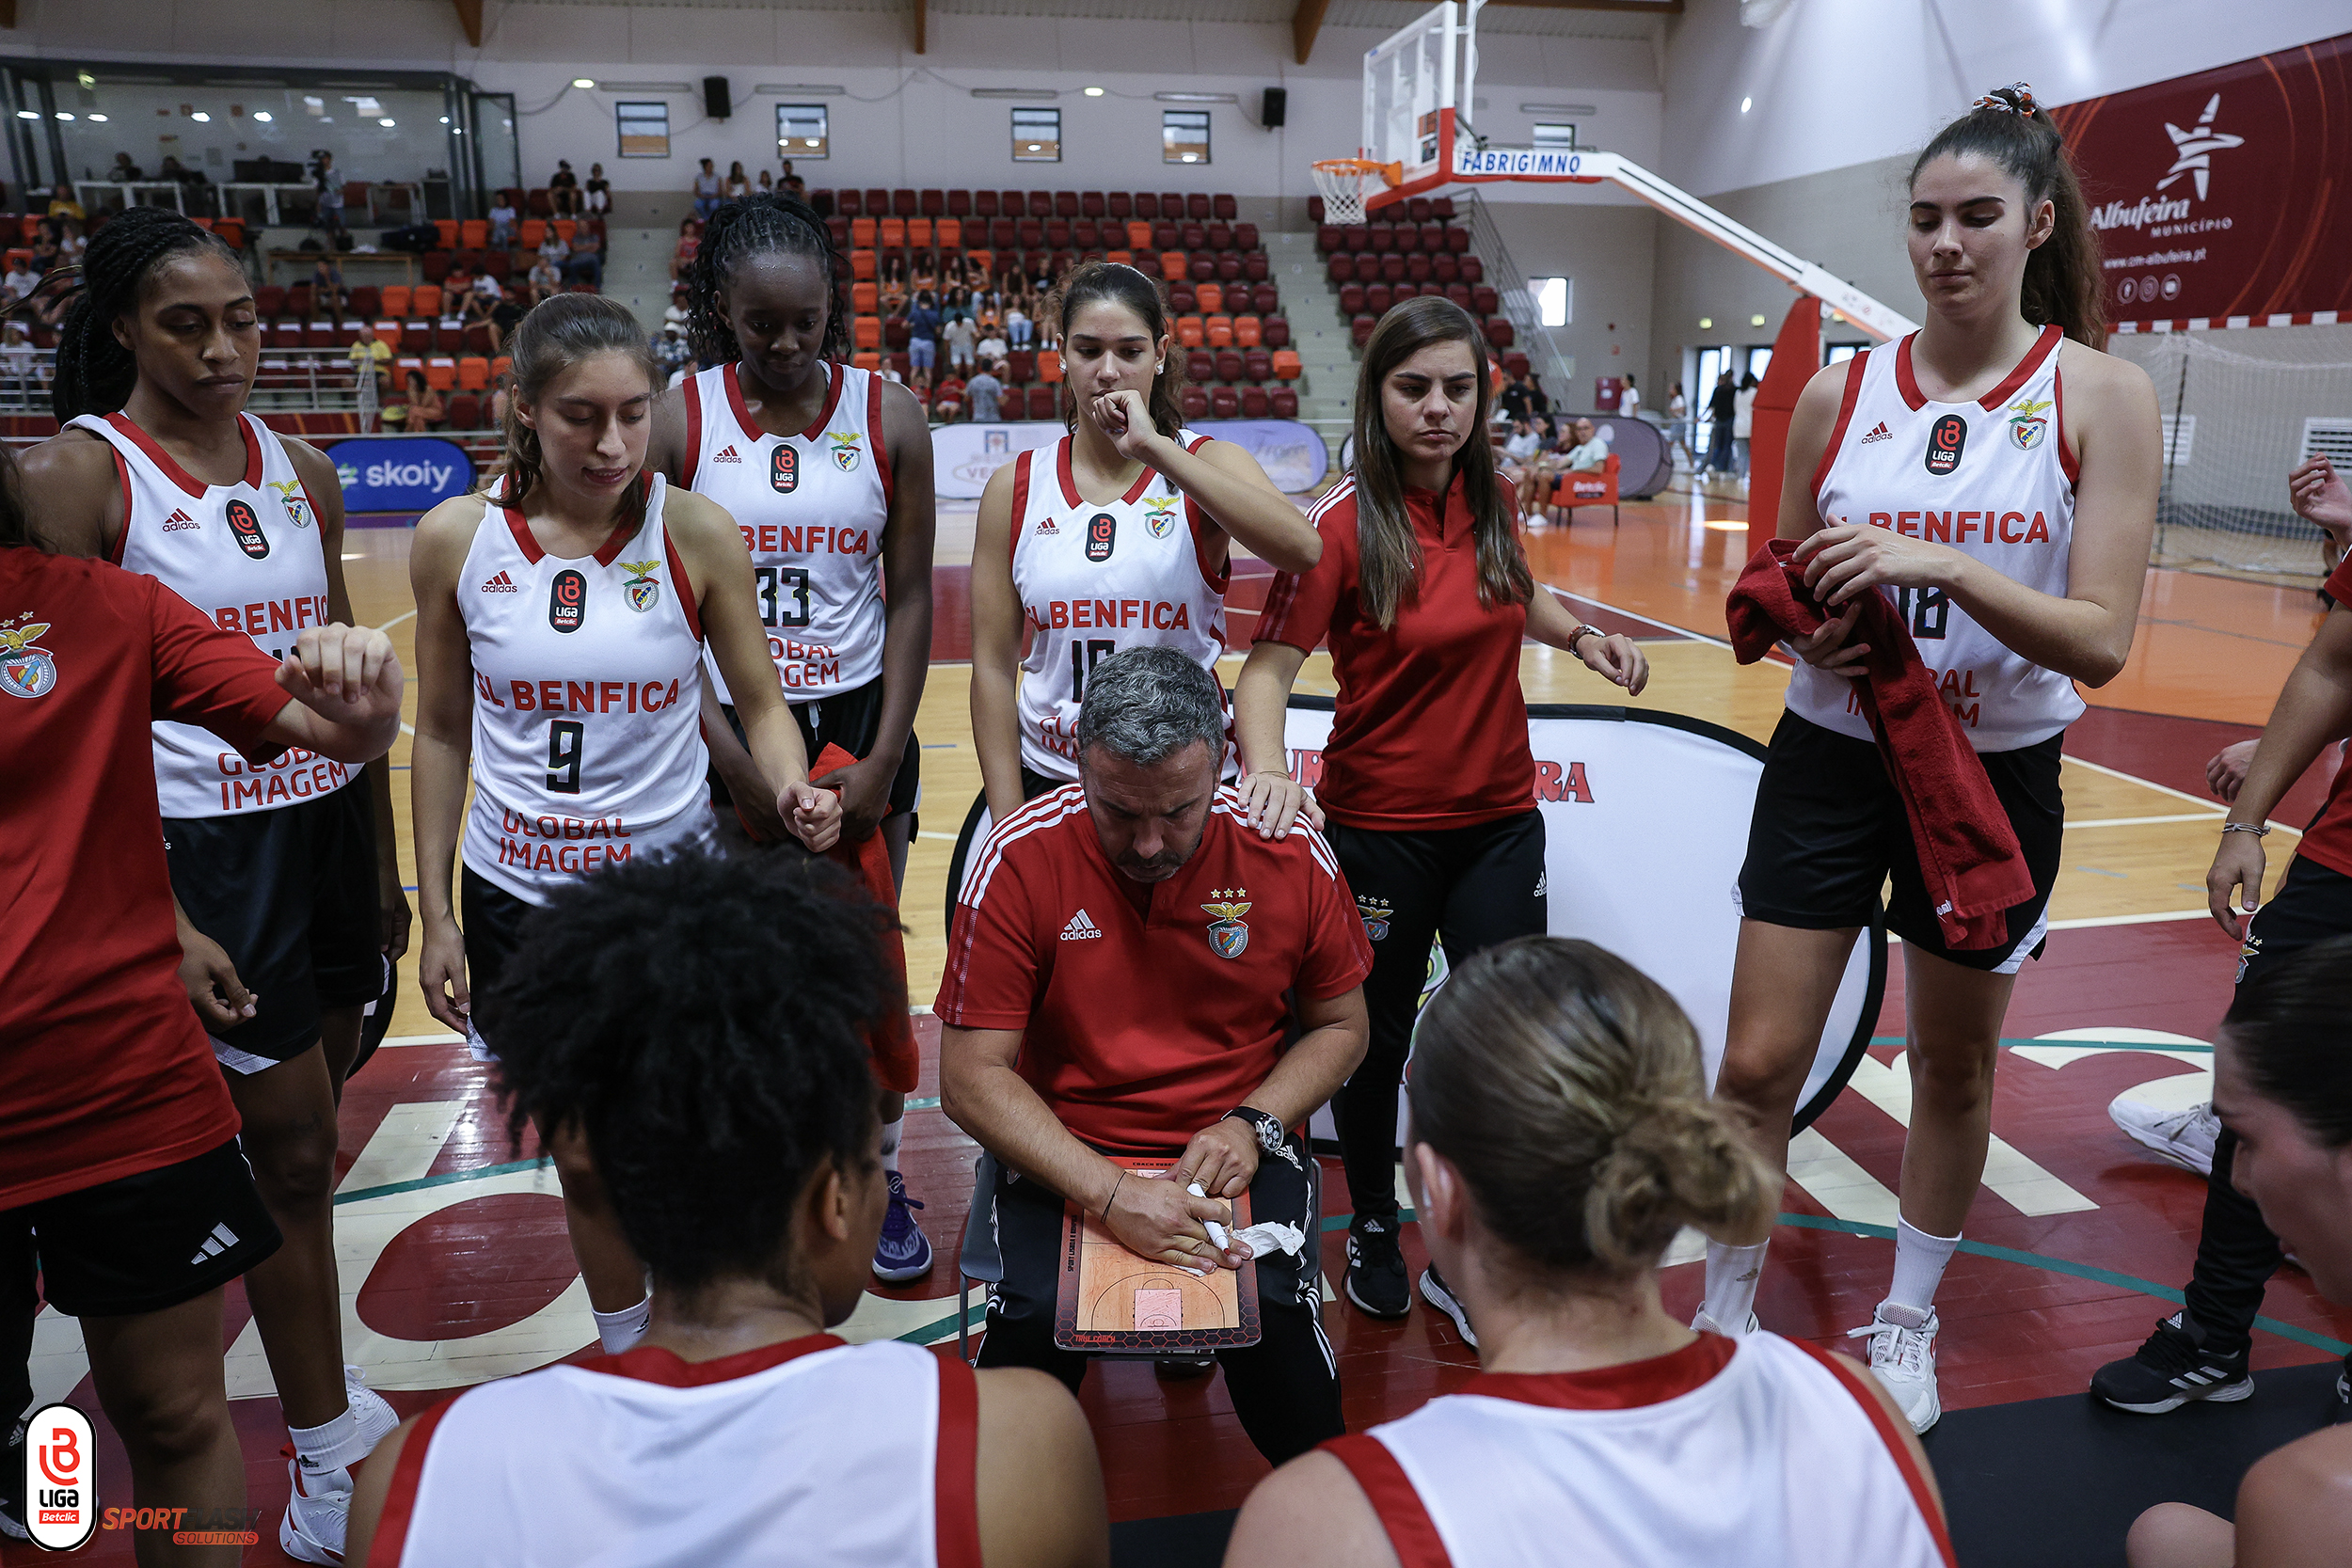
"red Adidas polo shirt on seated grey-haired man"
934,785,1372,1154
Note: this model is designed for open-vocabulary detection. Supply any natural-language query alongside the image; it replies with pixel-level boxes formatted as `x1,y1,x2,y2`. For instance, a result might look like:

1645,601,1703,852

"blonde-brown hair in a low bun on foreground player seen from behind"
1406,936,1781,1279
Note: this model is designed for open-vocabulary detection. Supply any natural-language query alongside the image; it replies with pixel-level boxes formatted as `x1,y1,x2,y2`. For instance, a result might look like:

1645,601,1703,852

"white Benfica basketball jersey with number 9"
456,475,710,903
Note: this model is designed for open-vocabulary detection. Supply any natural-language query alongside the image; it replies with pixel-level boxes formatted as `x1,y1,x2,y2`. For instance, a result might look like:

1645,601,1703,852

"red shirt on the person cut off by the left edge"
0,547,287,1211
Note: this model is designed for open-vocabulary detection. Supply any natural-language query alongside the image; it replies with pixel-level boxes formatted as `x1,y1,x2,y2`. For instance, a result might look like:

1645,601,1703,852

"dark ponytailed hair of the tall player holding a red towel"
1910,82,2107,348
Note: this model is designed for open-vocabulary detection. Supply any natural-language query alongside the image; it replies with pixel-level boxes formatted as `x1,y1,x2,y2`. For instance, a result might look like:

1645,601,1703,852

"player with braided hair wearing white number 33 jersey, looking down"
647,195,934,1284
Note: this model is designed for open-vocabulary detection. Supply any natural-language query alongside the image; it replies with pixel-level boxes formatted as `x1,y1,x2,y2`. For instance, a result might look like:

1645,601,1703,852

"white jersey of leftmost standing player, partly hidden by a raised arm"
69,414,353,816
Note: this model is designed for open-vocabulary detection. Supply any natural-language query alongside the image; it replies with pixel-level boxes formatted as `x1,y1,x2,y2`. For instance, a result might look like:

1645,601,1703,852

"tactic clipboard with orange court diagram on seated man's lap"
1054,1157,1263,1359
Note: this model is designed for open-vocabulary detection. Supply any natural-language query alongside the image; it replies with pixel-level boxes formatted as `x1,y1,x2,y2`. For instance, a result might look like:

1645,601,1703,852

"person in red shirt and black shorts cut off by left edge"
0,512,400,1561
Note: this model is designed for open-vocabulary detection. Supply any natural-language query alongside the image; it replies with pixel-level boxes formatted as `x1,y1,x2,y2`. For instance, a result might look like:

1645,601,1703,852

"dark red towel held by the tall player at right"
1724,538,2035,950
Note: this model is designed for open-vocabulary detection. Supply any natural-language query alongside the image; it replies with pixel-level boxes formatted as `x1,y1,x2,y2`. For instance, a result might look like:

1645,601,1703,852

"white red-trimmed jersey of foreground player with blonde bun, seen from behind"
1331,1333,1957,1568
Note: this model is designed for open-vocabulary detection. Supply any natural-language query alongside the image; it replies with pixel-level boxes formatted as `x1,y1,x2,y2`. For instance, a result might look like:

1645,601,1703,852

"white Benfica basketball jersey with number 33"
685,362,892,703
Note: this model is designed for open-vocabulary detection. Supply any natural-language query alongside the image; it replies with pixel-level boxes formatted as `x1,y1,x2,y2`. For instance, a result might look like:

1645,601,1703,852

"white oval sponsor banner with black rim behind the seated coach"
948,698,1886,1138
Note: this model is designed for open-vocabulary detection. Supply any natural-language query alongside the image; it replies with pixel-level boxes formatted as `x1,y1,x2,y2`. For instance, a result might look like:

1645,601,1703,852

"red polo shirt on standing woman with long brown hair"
1259,475,1536,832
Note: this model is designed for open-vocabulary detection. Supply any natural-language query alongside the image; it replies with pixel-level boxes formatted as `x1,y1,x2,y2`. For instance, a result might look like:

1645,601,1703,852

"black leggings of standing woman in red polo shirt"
1327,811,1546,1220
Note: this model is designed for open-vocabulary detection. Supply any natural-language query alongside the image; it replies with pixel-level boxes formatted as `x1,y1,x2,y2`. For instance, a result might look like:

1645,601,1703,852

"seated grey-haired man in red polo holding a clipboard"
936,646,1372,1465
